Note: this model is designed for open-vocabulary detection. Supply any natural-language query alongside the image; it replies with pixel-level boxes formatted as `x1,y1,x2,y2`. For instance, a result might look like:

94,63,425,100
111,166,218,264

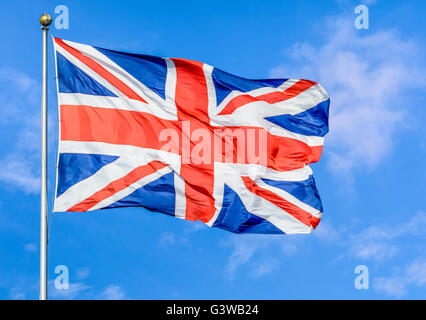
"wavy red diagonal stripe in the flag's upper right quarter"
219,80,317,115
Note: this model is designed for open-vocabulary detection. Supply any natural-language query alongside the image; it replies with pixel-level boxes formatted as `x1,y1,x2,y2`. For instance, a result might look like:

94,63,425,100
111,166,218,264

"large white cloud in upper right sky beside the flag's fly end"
271,16,426,179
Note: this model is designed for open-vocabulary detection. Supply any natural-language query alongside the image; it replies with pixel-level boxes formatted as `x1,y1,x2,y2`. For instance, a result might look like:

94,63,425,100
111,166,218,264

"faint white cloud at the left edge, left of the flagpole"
0,68,41,193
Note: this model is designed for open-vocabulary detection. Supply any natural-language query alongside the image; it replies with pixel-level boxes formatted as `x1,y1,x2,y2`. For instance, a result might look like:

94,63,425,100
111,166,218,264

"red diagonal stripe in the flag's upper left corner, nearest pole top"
54,38,146,103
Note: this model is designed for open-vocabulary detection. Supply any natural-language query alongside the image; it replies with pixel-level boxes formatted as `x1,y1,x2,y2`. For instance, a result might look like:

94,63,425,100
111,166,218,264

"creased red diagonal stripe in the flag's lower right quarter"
241,177,320,229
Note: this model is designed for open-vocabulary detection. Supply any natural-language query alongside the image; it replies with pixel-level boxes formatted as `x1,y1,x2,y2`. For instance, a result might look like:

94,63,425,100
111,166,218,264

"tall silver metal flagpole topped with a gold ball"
40,13,52,300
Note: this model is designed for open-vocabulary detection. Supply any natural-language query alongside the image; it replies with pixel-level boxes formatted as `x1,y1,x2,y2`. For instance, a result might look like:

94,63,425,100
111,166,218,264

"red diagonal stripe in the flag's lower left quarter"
67,161,167,212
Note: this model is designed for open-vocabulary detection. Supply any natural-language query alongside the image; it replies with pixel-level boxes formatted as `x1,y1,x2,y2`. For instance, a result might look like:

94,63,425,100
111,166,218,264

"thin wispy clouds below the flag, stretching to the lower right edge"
222,211,426,296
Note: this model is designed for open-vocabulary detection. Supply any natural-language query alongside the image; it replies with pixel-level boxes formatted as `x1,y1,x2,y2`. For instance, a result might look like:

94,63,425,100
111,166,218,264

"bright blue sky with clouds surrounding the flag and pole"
0,0,426,299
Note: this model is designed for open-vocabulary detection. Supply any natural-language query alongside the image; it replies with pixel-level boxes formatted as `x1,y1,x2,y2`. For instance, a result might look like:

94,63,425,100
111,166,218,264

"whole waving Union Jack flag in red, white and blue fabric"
54,38,329,234
